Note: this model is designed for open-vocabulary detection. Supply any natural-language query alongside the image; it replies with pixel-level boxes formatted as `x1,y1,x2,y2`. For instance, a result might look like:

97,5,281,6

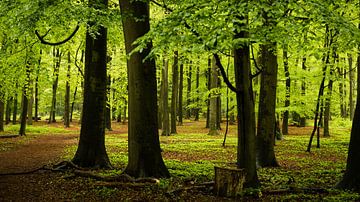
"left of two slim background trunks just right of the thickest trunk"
161,59,170,136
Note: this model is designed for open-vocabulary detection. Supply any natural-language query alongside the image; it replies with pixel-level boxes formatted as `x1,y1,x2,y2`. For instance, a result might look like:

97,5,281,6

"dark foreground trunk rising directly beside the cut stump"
234,21,260,187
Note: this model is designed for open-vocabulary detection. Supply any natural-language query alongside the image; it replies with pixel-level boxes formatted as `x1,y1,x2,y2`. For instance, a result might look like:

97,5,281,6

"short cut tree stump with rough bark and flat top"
214,166,245,197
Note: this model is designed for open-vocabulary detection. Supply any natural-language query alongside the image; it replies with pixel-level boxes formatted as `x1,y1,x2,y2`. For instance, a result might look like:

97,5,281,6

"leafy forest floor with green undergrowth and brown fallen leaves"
0,119,360,201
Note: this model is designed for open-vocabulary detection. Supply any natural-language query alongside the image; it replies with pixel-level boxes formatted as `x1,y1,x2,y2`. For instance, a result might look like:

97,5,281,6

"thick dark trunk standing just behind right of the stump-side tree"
256,43,279,167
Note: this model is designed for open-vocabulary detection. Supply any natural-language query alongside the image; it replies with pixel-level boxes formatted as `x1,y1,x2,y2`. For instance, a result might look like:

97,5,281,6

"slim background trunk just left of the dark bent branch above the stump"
208,56,220,135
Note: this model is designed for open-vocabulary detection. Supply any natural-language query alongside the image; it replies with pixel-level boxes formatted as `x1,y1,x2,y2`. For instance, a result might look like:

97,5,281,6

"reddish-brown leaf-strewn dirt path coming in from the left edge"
0,134,79,173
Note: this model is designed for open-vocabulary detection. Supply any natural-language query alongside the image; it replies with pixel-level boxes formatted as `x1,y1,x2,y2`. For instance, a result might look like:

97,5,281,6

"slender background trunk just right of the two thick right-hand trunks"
282,45,291,135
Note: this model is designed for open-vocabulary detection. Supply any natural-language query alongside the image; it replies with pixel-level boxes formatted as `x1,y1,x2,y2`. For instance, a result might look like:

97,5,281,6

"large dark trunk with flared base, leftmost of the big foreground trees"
72,0,111,168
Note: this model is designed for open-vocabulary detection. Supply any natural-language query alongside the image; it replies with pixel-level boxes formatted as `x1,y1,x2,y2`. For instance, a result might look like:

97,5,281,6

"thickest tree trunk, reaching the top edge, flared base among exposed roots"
120,0,169,178
